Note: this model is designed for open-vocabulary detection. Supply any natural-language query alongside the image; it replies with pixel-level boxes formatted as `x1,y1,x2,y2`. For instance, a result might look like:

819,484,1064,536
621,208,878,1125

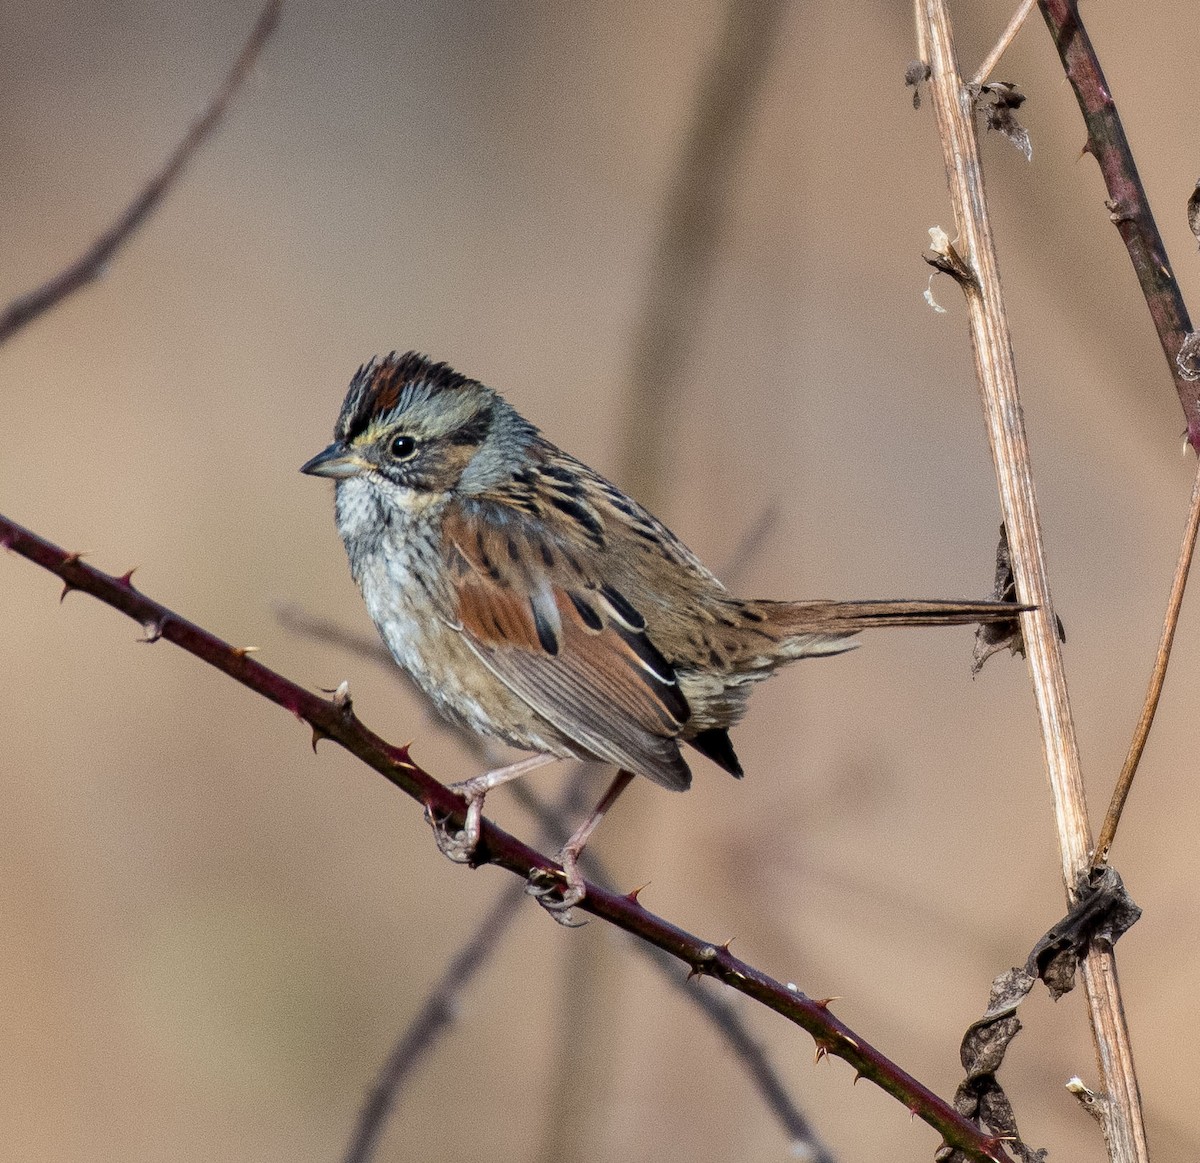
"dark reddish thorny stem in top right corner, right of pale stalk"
1038,0,1200,449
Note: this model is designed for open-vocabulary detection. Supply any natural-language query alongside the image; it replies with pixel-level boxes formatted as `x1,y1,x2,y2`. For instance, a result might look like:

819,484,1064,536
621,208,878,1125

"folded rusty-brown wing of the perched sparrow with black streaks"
443,499,691,791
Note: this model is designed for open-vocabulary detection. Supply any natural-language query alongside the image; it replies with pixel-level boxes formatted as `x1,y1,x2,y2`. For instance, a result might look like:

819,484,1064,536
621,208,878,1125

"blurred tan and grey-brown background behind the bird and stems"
0,0,1200,1163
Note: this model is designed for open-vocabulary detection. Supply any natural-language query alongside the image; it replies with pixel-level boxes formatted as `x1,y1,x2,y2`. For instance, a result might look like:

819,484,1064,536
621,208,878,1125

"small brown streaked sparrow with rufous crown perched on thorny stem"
300,352,1027,913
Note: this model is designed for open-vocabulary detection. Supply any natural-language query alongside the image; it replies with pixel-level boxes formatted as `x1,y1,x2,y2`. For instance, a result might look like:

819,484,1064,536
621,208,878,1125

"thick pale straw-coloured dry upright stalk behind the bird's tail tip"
916,0,1148,1163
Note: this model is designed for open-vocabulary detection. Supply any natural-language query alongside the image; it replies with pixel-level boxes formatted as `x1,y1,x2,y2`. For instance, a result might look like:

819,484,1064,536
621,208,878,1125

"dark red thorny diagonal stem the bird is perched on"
0,516,1010,1163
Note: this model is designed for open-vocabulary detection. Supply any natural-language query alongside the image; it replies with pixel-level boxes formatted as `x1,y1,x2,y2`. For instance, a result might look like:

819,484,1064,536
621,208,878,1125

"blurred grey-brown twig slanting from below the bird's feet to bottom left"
344,885,526,1163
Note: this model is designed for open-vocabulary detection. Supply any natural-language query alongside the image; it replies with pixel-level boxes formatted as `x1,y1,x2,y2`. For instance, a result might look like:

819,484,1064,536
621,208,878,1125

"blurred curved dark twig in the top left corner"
0,0,283,343
